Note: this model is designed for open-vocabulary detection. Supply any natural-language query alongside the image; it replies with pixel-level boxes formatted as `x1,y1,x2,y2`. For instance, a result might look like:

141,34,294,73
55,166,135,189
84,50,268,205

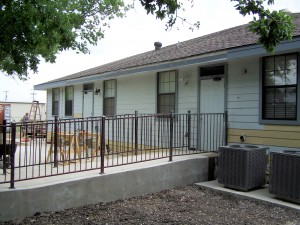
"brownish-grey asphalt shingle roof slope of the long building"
40,13,300,83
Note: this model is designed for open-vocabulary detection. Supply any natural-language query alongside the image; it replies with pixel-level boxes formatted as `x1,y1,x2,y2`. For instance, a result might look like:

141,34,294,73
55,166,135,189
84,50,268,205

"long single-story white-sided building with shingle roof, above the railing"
34,13,300,151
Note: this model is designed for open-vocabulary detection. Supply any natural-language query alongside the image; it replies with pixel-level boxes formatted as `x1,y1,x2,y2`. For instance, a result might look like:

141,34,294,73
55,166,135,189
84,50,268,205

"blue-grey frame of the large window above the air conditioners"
259,52,300,125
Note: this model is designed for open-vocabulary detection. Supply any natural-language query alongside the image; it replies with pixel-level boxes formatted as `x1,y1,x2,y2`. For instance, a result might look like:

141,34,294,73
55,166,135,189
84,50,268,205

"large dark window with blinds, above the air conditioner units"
262,54,298,120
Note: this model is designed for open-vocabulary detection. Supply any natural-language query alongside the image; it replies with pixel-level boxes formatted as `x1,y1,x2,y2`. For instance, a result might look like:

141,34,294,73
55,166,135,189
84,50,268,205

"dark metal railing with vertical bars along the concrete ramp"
0,112,227,188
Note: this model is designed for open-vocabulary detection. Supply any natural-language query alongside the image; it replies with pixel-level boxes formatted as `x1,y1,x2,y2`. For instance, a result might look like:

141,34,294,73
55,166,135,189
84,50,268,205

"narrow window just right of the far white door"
103,80,116,116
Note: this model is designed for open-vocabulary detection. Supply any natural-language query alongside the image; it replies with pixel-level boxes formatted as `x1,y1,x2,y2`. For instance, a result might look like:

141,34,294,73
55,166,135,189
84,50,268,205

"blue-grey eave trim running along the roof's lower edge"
34,36,300,90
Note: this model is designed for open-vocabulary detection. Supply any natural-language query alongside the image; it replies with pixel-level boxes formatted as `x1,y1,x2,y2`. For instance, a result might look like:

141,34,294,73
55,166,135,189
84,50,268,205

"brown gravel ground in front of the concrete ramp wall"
0,185,300,225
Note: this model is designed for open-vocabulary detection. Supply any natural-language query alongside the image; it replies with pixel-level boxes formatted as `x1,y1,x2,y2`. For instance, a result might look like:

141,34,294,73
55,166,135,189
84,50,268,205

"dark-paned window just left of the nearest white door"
157,71,176,113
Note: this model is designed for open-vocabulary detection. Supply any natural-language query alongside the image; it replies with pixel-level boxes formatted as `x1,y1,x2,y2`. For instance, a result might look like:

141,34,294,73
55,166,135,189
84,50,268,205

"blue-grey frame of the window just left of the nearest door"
156,70,178,114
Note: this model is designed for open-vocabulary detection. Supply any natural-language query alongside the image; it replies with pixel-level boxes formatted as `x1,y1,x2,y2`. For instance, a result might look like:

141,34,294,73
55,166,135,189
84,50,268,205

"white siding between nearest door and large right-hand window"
227,58,263,129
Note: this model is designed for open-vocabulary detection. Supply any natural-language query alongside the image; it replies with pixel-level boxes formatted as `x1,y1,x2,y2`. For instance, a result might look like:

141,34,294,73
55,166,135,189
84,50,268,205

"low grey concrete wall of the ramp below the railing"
0,156,208,221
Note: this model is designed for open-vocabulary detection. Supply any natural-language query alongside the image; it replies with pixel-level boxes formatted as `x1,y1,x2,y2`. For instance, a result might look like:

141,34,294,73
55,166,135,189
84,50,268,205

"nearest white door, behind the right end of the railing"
199,78,225,151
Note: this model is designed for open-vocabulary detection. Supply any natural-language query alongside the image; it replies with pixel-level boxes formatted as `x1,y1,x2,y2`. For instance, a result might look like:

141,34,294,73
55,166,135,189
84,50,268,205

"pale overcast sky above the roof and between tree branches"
0,0,300,102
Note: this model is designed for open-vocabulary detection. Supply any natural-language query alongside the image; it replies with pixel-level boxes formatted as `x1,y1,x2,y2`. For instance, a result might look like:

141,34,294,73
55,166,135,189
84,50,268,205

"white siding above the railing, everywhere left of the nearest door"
47,66,206,119
